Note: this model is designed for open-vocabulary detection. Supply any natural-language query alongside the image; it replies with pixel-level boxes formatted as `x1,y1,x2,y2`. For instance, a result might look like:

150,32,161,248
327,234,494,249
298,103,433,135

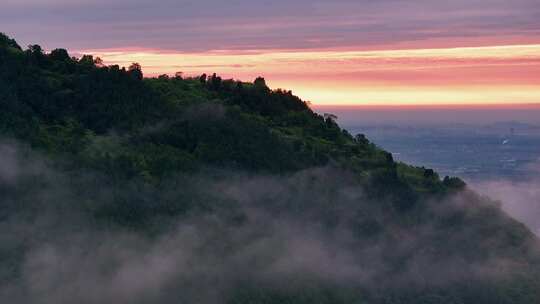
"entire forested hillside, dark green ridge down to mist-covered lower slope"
0,34,540,304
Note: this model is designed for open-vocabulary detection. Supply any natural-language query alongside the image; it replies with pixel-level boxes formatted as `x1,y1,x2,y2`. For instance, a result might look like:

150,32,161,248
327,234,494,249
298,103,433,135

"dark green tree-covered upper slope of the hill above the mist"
0,36,451,192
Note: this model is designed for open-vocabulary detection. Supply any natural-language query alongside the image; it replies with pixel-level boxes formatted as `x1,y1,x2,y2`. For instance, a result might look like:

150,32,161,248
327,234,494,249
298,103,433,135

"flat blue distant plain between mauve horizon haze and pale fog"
344,122,540,181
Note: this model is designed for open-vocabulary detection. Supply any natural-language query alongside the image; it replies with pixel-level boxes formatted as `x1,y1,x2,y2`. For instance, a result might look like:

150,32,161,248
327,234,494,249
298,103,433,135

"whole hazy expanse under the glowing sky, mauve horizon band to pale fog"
315,105,540,234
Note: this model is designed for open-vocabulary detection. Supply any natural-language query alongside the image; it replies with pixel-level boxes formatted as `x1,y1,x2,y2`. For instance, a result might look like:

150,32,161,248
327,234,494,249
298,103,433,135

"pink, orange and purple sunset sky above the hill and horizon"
0,0,540,105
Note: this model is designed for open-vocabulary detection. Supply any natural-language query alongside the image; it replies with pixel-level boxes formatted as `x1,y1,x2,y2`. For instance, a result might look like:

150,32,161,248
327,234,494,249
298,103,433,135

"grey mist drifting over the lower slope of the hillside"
0,141,532,304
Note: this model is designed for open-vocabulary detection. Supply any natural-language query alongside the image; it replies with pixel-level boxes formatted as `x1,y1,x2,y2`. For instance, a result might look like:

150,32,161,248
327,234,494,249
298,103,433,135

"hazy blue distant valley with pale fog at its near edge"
334,113,540,235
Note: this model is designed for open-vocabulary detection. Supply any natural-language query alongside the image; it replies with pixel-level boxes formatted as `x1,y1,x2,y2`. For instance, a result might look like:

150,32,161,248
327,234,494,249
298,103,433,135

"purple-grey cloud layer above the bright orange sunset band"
0,0,540,51
